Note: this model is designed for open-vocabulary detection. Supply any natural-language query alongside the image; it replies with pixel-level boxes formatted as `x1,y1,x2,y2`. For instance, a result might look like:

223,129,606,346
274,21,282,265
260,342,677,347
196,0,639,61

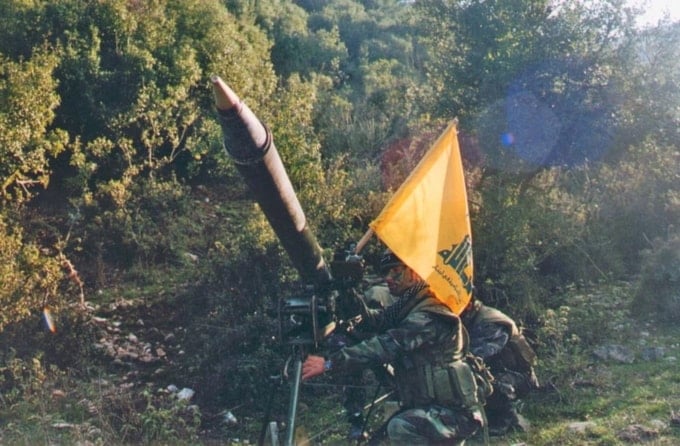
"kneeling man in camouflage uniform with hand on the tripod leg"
302,251,484,445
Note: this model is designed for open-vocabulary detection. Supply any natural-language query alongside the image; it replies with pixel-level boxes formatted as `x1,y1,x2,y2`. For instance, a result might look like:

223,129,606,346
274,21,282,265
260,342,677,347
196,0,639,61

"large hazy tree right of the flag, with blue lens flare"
416,0,678,318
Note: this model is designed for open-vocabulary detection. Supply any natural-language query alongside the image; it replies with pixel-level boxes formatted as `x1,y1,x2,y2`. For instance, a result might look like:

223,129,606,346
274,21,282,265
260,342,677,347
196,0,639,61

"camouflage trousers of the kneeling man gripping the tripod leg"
387,406,481,446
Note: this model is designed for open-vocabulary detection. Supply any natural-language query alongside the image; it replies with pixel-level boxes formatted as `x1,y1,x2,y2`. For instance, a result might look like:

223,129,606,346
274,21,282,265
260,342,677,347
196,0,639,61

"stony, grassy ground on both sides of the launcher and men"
0,278,680,445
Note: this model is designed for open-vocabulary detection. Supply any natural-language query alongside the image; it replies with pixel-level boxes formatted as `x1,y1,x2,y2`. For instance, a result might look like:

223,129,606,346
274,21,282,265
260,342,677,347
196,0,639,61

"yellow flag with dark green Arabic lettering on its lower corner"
369,121,473,314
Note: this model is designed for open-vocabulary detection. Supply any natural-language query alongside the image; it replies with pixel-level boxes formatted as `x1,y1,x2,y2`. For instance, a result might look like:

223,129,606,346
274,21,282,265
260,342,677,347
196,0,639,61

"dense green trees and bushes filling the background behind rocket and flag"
0,0,680,444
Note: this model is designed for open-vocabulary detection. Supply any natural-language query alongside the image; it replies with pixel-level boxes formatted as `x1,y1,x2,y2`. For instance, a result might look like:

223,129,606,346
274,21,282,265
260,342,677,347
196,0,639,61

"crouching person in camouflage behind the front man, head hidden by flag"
461,298,539,436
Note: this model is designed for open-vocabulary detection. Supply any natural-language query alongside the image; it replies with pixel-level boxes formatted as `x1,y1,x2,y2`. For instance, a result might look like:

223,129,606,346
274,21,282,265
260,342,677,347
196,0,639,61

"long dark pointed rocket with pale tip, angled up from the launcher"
211,76,331,286
